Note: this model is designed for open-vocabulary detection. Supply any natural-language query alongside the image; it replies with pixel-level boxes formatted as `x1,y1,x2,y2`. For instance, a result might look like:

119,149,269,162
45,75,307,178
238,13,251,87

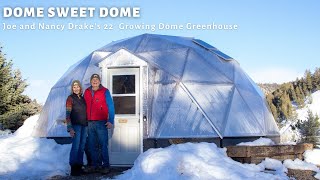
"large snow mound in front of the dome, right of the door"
117,143,287,180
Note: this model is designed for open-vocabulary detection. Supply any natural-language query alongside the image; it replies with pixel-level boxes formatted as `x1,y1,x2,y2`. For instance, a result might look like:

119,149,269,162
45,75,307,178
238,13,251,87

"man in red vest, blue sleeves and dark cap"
84,74,114,174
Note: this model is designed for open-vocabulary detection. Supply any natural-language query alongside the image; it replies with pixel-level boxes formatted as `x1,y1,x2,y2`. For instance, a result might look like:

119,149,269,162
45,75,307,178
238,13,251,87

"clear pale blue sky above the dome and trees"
0,0,320,103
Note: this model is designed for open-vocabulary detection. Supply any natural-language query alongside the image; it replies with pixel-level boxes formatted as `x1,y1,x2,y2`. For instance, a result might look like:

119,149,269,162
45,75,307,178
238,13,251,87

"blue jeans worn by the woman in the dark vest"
69,125,87,165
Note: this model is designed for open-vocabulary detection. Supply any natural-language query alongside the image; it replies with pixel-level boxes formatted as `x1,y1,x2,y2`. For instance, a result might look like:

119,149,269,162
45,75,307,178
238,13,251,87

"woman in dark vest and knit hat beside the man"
66,80,88,176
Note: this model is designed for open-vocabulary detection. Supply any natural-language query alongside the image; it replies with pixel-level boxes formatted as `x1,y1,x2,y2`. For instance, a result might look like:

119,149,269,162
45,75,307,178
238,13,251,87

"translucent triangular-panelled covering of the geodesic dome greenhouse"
33,34,279,138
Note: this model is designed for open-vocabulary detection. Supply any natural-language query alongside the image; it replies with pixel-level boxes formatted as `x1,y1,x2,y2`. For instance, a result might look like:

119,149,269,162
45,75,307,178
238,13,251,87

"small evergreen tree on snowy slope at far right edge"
298,110,320,145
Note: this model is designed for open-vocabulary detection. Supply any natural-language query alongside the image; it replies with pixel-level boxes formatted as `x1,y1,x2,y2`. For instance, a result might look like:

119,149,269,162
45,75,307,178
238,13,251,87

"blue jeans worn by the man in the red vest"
88,120,110,167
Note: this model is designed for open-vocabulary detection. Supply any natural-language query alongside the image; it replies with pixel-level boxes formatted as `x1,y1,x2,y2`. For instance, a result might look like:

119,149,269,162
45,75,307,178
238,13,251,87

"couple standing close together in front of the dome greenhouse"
66,74,115,176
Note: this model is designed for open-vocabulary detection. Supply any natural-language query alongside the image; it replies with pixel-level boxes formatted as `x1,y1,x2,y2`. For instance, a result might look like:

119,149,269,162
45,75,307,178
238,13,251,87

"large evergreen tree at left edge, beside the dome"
0,48,41,130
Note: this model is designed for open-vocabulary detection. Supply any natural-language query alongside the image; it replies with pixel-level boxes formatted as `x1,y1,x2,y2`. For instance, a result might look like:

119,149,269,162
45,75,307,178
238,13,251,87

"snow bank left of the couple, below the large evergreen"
0,116,71,179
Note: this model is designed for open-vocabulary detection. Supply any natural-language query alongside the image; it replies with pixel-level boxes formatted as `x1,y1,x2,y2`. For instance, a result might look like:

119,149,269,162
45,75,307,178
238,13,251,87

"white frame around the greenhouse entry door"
100,66,147,167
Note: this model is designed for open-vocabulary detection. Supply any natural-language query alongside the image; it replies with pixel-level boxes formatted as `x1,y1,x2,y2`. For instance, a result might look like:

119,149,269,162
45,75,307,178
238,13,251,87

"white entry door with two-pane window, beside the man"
107,68,141,166
